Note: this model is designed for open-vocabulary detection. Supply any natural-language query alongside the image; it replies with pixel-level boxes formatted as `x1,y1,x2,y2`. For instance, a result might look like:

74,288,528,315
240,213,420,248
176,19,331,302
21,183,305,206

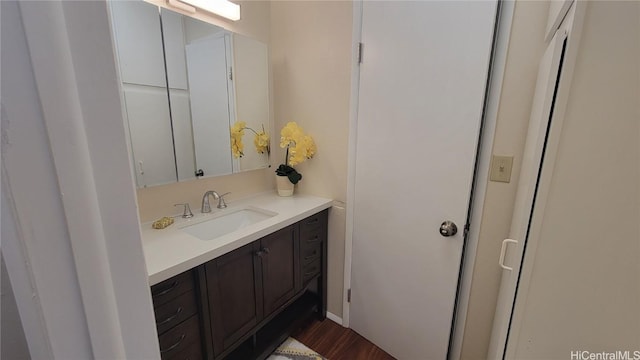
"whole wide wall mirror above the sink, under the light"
110,1,270,187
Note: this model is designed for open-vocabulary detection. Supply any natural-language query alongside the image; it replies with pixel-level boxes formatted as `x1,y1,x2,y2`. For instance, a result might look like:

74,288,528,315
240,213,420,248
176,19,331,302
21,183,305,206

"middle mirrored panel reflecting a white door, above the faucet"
161,9,235,180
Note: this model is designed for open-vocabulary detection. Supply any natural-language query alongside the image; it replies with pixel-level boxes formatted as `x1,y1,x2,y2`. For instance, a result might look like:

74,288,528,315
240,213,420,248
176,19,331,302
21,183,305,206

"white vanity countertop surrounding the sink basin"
142,192,332,285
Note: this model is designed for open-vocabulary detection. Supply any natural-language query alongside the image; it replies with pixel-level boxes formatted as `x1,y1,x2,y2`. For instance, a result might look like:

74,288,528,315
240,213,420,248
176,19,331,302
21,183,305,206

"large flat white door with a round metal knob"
350,1,496,359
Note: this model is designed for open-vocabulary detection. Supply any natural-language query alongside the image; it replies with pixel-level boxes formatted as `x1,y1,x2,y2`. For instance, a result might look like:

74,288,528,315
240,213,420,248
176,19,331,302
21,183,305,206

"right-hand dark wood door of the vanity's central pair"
260,226,300,316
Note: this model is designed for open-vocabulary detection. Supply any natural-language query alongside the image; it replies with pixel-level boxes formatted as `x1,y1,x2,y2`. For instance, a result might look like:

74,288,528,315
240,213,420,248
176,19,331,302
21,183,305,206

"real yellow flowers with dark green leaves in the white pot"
276,122,317,184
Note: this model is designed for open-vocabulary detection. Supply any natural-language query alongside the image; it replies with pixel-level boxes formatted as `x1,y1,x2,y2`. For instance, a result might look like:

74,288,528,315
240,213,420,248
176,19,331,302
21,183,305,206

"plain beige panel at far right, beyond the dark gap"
508,1,640,359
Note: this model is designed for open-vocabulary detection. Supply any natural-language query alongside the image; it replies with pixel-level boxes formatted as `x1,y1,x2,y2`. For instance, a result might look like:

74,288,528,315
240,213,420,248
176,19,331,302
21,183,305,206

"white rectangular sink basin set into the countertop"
182,208,277,240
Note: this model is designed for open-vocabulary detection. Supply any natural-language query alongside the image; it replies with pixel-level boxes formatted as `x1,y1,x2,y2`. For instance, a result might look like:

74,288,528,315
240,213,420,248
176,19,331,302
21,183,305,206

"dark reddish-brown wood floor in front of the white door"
293,319,395,360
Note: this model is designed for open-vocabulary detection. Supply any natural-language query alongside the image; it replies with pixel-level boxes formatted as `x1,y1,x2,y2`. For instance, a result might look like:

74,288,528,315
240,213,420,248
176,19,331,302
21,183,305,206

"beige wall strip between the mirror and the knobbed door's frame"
271,1,353,316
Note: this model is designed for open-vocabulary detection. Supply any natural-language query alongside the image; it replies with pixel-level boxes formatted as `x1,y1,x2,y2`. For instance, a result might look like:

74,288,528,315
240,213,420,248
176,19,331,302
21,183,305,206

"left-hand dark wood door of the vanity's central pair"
205,241,263,355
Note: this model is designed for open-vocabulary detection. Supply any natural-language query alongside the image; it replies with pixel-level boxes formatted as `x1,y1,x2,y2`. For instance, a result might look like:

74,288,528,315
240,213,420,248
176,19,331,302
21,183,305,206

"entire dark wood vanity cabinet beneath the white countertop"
152,210,328,360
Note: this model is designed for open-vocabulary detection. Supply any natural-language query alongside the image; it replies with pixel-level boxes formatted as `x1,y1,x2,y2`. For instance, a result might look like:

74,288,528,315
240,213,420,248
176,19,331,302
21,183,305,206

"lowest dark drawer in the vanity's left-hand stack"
158,316,201,360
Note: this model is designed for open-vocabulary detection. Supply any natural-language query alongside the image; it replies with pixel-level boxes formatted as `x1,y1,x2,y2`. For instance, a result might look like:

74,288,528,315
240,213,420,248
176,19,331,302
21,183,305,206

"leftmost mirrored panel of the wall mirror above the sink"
110,1,177,187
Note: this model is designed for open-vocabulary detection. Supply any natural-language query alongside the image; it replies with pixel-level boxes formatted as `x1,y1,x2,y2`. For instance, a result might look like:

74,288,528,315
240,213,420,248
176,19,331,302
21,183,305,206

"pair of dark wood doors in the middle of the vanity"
204,225,301,356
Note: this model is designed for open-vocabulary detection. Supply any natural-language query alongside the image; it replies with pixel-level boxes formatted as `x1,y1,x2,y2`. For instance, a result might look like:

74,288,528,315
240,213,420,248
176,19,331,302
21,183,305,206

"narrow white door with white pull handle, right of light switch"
487,23,567,359
